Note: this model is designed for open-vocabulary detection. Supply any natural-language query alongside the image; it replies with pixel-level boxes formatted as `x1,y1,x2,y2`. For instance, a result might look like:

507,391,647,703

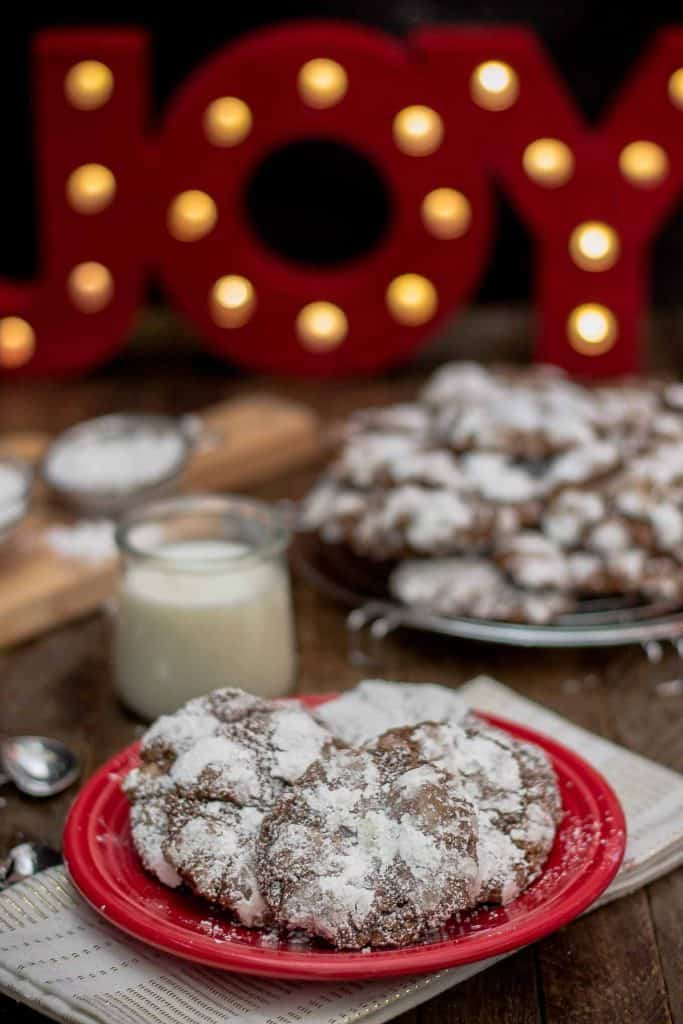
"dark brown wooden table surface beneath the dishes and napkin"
0,352,683,1024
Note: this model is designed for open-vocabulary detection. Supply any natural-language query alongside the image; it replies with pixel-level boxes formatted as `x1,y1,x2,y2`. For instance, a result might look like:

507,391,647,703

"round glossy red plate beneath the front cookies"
63,696,626,981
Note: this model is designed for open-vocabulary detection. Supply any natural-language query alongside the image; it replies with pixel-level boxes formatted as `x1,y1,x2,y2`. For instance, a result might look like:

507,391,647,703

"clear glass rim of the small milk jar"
115,494,291,572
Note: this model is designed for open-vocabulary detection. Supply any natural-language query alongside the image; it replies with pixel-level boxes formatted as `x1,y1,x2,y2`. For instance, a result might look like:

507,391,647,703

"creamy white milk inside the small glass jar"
115,541,295,719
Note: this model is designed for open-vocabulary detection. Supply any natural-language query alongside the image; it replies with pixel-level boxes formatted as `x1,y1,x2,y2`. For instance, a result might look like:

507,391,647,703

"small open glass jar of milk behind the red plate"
114,495,295,720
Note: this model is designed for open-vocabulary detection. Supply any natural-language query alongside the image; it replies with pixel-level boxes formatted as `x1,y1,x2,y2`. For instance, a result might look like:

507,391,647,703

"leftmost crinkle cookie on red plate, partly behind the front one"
123,689,337,926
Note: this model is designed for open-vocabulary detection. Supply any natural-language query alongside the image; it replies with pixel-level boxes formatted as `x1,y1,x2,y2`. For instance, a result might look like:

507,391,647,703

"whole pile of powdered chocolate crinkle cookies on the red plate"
123,681,561,949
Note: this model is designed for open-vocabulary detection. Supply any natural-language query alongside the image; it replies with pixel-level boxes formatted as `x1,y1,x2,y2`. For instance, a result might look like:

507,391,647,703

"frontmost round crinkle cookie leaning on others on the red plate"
258,744,477,949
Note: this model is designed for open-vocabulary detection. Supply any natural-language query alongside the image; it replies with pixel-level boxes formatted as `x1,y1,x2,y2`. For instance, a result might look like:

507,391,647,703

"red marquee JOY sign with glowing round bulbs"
0,23,683,375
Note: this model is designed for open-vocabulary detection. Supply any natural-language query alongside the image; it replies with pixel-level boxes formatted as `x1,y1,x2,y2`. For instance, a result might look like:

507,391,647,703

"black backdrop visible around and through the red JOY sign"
0,0,683,305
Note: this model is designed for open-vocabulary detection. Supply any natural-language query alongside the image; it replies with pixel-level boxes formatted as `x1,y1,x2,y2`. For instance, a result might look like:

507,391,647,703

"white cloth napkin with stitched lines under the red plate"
0,678,683,1024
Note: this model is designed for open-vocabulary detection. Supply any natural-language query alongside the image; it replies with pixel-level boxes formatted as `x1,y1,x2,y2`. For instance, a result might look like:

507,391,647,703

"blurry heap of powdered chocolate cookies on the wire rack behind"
302,362,683,623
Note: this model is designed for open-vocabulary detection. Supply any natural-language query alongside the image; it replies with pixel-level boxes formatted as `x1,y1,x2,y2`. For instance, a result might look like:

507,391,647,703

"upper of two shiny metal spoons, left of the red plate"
0,736,81,797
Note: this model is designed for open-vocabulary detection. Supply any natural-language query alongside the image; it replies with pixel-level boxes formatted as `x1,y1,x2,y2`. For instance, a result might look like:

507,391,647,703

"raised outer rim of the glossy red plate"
63,694,626,981
